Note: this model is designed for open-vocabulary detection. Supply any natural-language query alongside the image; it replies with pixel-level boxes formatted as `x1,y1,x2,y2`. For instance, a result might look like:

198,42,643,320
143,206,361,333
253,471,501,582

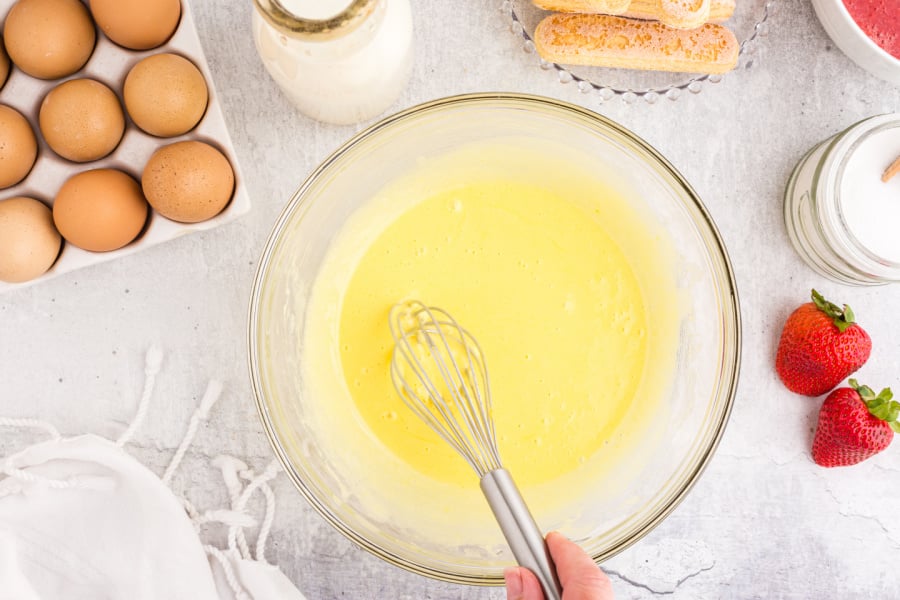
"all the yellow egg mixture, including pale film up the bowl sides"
306,142,678,502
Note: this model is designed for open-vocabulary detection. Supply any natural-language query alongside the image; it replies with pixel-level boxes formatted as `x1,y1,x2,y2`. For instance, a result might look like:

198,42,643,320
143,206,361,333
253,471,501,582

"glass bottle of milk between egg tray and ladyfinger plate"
253,0,413,124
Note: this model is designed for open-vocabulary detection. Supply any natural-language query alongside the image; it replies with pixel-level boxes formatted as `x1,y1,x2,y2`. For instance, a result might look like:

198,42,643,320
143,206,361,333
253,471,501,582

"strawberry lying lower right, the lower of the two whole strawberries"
813,379,900,467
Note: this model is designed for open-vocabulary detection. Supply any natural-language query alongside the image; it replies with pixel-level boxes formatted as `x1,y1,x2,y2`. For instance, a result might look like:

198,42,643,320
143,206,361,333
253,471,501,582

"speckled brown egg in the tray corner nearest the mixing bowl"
141,141,234,223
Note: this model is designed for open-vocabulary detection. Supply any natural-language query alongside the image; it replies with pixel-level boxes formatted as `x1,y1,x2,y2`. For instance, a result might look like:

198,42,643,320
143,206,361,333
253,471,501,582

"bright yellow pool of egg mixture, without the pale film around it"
340,180,655,485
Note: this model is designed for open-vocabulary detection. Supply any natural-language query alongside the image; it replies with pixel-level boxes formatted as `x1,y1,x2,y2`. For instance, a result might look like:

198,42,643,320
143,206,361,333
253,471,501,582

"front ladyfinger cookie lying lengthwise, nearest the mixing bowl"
534,13,739,73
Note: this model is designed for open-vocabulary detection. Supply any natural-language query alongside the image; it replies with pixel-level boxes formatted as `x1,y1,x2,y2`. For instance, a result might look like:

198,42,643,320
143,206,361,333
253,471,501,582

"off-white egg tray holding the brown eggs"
0,0,250,293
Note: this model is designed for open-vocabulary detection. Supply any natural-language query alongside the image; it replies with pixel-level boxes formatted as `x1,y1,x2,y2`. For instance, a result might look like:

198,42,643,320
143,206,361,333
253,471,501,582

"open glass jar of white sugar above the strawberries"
784,113,900,285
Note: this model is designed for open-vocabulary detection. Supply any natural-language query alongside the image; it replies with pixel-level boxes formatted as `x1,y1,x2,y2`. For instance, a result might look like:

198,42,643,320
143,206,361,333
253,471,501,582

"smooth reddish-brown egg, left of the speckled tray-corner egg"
53,169,148,252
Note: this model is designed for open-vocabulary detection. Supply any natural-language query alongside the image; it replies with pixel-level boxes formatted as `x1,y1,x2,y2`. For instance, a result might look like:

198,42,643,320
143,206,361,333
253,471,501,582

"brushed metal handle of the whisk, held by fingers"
481,469,562,600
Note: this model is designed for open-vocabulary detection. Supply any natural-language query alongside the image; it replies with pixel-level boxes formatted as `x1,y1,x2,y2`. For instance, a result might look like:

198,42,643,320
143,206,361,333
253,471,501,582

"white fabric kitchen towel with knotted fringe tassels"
0,348,303,600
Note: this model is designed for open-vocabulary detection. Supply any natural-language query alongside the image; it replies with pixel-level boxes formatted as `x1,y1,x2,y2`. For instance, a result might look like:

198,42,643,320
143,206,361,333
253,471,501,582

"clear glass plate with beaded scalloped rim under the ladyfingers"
502,0,777,104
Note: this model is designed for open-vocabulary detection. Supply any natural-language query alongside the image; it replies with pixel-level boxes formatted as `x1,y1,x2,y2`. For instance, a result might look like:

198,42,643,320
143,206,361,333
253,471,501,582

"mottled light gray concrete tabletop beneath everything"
0,0,900,600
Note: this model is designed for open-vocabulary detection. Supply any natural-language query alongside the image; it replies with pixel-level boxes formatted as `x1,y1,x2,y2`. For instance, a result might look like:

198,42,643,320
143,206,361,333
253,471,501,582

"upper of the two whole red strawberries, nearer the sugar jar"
775,290,872,396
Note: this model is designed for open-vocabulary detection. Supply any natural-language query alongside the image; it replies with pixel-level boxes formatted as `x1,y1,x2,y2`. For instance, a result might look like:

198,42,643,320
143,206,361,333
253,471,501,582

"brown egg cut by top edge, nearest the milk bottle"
91,0,181,50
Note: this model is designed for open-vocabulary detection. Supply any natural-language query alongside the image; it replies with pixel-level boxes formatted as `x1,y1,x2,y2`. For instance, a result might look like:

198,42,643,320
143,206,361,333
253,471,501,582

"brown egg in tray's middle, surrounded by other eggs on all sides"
39,79,125,162
